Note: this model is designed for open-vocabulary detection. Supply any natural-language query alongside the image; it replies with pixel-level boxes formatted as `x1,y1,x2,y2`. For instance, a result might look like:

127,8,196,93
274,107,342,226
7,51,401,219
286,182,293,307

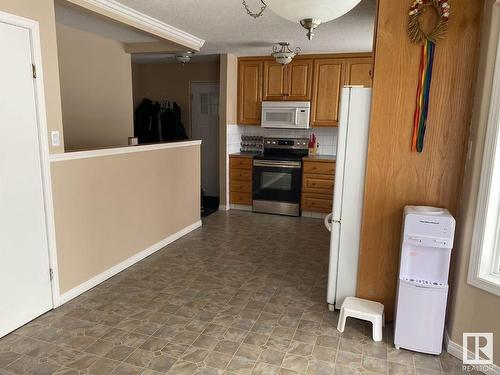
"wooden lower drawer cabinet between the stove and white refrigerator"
301,160,335,213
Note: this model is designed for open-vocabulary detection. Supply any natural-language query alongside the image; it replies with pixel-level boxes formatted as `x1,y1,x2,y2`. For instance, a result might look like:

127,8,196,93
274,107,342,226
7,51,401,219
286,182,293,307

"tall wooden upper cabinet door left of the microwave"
238,61,262,125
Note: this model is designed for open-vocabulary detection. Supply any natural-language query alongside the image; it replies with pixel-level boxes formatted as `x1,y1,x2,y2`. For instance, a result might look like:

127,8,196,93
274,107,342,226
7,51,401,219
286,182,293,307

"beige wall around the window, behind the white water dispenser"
447,0,500,365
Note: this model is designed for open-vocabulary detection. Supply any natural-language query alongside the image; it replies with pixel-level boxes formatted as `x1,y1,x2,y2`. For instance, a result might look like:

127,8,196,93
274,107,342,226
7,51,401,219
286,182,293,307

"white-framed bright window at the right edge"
468,26,500,296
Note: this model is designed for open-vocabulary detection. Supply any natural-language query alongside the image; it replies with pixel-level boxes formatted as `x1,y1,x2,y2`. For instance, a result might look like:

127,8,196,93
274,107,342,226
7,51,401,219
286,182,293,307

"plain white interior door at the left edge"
0,21,52,337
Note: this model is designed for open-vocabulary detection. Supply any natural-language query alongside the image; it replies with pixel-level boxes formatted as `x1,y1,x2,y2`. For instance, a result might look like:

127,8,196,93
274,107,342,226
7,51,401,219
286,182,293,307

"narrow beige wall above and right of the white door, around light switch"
0,0,64,153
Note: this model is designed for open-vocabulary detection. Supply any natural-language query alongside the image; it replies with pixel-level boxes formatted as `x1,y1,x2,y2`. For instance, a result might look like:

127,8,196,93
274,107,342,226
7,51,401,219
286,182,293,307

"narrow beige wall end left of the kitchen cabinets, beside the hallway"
219,54,238,205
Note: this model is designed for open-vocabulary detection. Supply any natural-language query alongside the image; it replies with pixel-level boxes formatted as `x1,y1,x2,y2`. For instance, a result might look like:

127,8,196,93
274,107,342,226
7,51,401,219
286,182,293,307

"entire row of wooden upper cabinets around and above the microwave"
238,54,372,127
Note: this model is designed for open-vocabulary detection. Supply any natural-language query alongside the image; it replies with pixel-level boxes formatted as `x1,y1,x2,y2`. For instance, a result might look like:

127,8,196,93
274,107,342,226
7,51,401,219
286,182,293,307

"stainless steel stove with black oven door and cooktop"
253,138,307,216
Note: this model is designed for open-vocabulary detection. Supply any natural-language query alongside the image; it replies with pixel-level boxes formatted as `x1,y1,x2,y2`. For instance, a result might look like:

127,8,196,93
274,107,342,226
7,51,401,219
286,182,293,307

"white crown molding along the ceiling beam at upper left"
66,0,205,51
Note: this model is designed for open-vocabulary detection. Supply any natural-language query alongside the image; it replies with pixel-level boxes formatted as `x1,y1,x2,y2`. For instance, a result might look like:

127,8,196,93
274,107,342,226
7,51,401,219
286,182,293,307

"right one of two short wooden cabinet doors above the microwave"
286,59,313,101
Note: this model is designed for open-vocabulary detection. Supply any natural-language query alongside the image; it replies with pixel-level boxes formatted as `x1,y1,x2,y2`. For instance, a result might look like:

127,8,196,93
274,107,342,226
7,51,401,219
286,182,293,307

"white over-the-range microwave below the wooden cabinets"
261,102,311,129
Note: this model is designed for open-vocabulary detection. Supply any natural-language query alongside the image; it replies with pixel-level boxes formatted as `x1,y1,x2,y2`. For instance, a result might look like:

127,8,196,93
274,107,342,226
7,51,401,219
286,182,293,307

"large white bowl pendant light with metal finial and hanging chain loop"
243,0,361,40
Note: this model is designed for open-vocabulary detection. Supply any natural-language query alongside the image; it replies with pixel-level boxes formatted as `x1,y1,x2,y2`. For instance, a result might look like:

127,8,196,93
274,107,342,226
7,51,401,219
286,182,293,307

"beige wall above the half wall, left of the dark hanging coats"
57,23,134,150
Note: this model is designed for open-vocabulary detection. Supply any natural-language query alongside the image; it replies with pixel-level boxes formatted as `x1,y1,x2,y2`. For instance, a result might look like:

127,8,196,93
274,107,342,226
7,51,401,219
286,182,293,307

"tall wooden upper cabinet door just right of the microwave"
311,59,345,126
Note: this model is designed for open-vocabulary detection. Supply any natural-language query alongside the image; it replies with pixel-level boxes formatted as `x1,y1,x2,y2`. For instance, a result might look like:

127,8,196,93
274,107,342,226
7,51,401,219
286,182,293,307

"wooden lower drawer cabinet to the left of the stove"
229,155,252,206
